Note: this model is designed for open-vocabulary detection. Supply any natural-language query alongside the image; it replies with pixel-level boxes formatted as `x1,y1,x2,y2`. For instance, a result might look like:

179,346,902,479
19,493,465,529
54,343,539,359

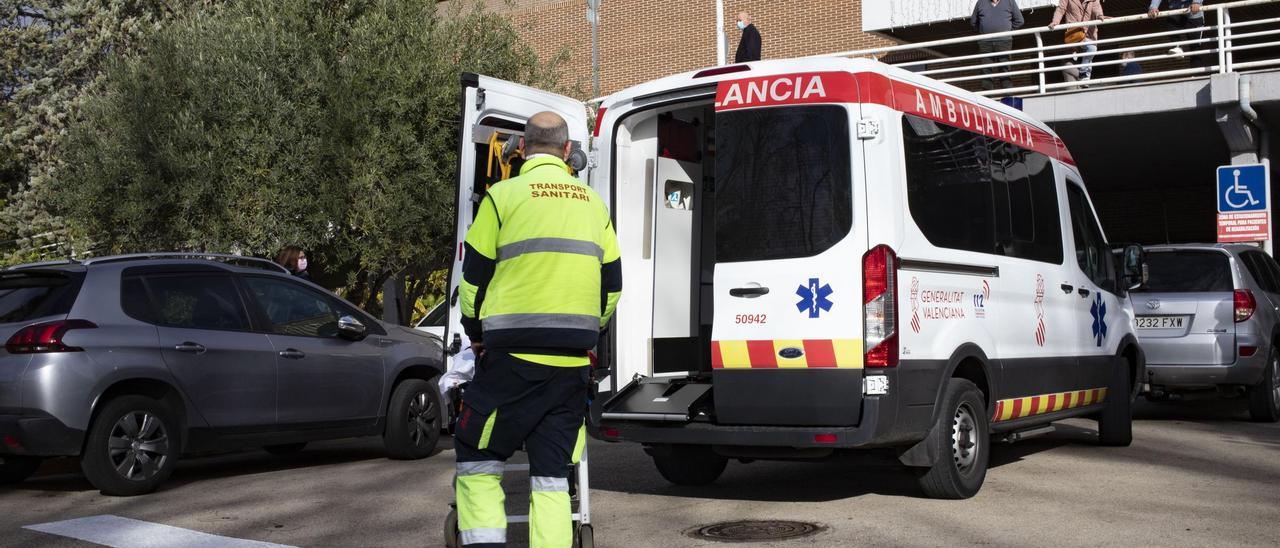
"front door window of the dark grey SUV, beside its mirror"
244,277,349,337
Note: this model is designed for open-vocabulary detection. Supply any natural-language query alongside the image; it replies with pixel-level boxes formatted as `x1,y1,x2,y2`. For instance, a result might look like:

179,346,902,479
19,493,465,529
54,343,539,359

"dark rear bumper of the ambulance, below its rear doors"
591,397,929,448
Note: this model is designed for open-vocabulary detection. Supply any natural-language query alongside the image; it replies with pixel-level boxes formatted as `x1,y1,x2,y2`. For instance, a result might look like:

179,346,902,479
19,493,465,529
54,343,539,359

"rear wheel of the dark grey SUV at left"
81,396,180,497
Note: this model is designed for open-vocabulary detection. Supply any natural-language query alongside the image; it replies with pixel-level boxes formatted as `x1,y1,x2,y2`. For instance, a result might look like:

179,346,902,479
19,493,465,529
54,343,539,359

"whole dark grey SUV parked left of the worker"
0,254,444,496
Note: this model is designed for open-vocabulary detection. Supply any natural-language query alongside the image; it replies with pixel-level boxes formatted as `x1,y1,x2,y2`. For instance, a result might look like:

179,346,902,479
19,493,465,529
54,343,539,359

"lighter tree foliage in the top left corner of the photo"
0,0,183,264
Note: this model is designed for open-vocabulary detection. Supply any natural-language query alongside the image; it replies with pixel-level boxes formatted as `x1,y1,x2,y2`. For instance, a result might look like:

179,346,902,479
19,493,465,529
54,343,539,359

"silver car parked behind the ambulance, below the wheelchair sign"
1132,245,1280,423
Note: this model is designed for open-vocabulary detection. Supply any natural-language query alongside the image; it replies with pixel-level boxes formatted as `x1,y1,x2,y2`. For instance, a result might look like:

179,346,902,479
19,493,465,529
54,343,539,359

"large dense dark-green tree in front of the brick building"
50,0,570,316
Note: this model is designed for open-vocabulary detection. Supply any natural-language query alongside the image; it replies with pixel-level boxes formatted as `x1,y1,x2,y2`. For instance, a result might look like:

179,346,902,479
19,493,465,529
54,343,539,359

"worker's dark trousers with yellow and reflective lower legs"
453,350,590,547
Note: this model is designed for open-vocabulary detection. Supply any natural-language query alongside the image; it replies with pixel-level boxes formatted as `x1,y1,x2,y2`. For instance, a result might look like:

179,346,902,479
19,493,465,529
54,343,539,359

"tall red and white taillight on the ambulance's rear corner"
863,245,897,367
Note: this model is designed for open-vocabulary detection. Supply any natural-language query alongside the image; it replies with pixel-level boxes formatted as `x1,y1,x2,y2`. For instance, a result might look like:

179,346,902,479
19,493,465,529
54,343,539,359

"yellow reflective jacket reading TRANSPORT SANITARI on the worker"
461,155,622,366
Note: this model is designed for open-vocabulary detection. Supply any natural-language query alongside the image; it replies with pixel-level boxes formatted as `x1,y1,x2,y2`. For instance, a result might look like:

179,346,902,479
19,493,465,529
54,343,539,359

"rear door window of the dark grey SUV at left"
146,275,250,330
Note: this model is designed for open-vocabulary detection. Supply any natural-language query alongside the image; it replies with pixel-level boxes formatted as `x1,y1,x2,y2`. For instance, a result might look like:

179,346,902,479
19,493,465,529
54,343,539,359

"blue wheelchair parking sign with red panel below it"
1217,164,1271,243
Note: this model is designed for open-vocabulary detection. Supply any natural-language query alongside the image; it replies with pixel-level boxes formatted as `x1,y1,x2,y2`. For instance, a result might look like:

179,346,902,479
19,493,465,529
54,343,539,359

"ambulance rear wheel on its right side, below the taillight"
919,379,991,499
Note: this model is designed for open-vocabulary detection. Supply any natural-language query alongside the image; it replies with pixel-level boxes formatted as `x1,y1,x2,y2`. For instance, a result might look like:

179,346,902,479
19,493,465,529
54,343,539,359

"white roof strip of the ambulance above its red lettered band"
600,58,1057,151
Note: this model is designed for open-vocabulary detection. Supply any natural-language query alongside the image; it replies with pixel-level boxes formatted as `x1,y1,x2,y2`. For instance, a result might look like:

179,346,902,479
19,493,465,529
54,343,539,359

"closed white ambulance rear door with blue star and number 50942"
710,72,868,427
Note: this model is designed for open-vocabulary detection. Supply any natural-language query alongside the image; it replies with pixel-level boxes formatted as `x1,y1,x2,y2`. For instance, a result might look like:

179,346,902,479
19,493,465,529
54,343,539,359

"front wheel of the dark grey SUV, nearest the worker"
383,379,444,460
